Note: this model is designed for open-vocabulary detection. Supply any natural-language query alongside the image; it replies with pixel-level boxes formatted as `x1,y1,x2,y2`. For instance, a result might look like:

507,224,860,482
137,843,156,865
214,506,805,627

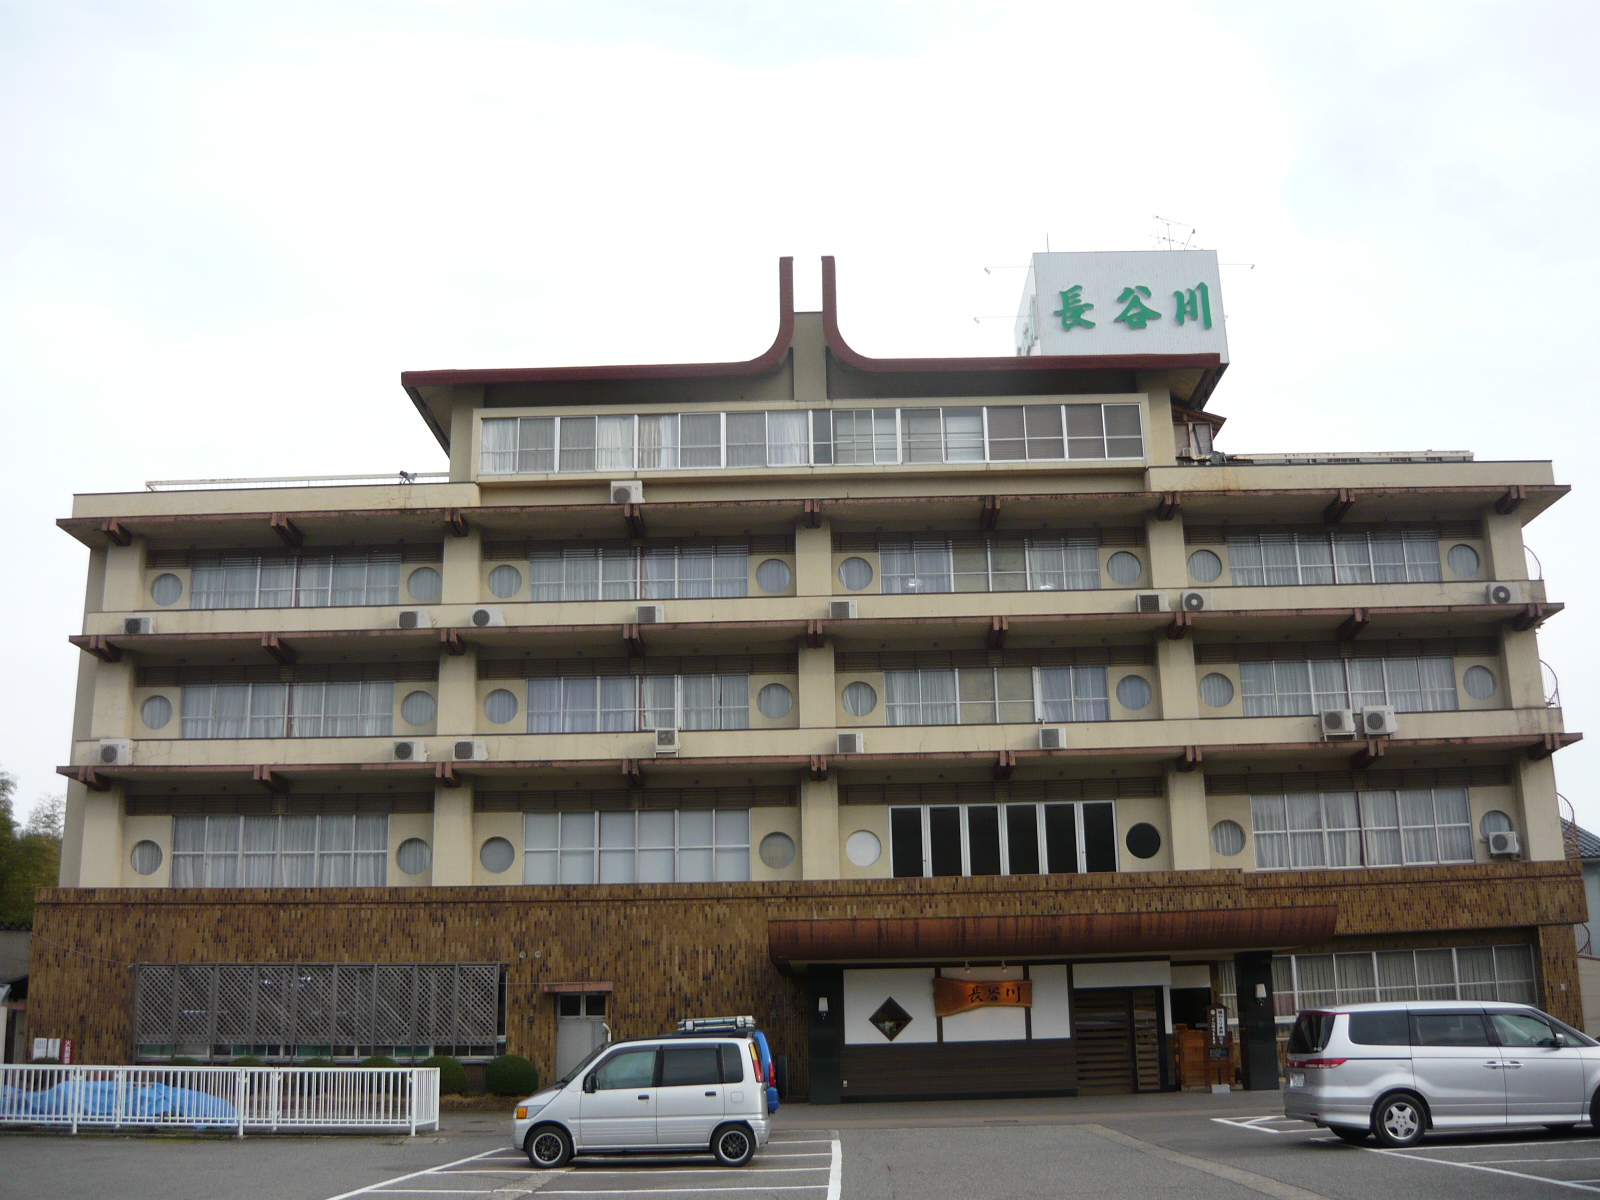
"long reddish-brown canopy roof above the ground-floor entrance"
766,904,1339,971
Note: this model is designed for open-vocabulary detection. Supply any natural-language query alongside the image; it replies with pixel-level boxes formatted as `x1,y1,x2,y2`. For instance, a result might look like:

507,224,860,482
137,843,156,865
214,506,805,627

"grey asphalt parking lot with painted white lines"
9,1093,1600,1200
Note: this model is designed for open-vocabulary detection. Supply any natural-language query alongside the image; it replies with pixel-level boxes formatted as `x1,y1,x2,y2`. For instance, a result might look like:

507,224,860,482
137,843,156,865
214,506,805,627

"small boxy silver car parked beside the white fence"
512,1022,771,1170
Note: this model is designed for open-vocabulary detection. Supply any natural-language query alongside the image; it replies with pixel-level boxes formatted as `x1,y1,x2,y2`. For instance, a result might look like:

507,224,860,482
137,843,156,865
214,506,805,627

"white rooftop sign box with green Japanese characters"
1016,250,1227,363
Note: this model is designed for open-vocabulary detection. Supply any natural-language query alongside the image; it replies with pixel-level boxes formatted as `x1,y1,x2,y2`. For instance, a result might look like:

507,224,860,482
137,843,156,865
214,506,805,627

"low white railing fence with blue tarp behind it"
0,1066,438,1138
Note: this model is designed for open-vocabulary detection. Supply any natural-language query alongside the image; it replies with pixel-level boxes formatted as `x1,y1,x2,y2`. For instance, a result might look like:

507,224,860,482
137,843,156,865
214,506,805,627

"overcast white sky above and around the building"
0,0,1600,829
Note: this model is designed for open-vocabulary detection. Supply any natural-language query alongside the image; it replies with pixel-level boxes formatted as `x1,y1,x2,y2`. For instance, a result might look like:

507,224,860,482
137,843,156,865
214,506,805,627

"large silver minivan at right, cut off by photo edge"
1283,1000,1600,1146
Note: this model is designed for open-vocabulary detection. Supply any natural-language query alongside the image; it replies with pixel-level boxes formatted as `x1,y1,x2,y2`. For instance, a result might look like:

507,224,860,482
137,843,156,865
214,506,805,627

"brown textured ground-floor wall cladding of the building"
29,862,1586,1094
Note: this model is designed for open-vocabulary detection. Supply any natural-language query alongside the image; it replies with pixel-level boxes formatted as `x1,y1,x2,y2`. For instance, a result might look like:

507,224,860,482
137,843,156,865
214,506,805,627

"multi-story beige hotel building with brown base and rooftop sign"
29,253,1586,1101
